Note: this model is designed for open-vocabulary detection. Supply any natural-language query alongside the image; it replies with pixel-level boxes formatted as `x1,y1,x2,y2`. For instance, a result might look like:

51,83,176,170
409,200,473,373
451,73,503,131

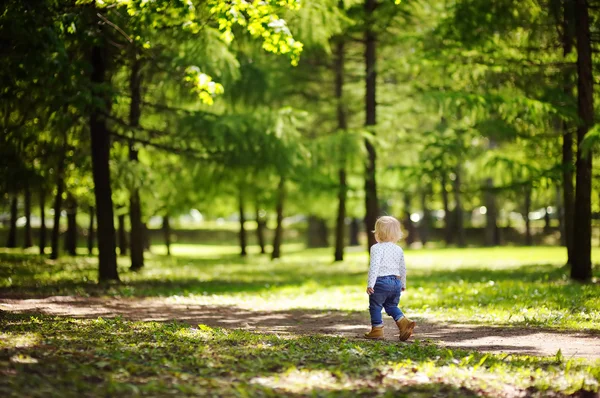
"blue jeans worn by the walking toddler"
369,275,404,326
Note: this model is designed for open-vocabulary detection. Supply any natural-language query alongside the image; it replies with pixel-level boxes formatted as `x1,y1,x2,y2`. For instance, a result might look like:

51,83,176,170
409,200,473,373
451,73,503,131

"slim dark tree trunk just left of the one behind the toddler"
334,32,348,261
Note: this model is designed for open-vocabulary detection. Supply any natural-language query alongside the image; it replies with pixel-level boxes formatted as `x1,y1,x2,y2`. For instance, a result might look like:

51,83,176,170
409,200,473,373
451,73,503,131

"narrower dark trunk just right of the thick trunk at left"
129,54,144,270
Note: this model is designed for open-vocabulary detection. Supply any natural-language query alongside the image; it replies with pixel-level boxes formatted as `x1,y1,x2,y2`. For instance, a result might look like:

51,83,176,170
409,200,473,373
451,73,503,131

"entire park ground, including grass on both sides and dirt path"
0,245,600,397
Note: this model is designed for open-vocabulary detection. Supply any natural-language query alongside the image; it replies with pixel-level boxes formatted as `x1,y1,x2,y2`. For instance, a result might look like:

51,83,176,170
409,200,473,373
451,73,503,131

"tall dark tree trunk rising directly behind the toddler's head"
364,0,379,251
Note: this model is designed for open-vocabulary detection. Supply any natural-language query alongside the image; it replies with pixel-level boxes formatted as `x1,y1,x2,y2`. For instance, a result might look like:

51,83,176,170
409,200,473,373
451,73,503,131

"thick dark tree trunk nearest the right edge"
571,0,594,281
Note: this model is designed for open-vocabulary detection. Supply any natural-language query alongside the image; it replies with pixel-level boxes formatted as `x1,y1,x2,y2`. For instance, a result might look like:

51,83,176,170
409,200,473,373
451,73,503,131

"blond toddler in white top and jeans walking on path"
365,216,416,341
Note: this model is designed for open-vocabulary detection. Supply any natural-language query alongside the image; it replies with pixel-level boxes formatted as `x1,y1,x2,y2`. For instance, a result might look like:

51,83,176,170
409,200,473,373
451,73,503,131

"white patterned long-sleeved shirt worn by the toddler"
367,242,406,288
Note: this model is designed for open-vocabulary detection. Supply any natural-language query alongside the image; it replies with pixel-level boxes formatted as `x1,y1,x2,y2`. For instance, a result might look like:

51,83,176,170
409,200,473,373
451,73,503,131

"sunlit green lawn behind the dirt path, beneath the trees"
0,245,600,333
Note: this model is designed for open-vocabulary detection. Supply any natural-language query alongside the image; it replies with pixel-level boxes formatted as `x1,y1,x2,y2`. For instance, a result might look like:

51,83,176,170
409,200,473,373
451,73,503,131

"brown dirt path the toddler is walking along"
0,296,600,359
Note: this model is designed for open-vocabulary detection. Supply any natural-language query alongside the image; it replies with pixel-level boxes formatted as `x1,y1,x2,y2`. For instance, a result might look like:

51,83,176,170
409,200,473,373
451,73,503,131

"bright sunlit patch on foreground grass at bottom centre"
250,368,350,394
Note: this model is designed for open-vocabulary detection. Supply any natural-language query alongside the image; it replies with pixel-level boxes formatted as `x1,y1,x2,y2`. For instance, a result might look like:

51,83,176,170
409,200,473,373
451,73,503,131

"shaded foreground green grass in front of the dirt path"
0,313,600,397
